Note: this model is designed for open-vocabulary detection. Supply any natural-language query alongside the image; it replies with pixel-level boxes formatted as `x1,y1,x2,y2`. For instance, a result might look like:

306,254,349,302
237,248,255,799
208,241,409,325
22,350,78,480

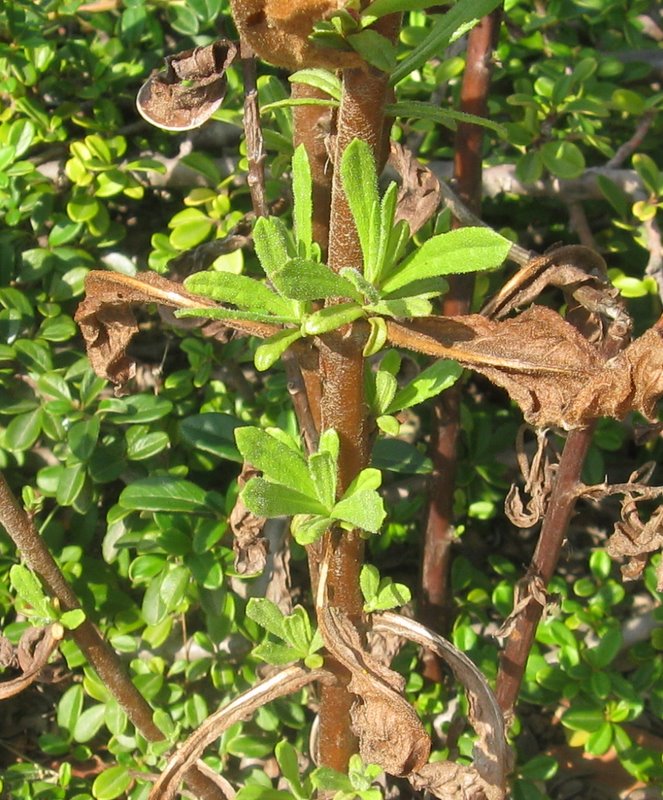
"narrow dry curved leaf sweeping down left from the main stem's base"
149,666,331,800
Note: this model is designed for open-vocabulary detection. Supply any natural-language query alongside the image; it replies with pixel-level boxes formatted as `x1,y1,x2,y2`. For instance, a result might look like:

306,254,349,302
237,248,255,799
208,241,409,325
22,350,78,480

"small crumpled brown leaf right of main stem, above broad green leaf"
389,142,442,235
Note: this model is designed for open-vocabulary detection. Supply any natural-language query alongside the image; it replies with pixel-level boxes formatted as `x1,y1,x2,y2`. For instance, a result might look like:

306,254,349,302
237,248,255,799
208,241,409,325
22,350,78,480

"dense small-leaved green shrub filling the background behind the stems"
0,0,663,800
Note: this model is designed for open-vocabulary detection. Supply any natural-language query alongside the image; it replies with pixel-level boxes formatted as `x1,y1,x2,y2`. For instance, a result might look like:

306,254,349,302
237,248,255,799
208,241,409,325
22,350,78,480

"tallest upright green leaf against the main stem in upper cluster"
341,139,380,270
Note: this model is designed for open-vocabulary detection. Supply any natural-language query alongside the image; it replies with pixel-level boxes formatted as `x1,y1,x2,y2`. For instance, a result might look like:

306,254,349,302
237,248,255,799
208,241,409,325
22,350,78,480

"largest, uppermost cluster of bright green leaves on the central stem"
177,140,511,370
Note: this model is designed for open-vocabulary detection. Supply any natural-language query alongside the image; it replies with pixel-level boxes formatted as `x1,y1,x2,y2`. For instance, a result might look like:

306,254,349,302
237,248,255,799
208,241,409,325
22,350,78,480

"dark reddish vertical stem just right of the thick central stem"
420,11,500,681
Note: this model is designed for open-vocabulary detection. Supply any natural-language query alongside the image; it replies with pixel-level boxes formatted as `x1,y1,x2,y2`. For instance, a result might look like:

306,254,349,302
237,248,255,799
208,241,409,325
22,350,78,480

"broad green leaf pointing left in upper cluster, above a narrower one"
184,272,293,317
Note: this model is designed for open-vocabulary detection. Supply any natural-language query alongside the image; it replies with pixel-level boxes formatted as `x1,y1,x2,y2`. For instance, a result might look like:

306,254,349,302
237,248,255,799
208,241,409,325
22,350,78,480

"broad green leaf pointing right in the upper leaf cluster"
382,228,511,293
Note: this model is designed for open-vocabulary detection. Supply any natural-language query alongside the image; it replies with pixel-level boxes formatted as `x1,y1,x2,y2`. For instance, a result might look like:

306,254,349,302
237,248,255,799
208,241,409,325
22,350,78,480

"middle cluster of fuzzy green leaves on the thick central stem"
235,426,386,544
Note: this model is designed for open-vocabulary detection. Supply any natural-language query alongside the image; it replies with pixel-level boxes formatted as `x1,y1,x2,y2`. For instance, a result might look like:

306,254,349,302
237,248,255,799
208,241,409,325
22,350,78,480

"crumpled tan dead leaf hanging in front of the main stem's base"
318,606,431,775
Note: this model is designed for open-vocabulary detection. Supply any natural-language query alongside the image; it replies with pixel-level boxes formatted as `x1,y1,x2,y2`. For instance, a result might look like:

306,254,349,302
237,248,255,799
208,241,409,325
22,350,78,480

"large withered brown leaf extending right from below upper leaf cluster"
387,306,663,429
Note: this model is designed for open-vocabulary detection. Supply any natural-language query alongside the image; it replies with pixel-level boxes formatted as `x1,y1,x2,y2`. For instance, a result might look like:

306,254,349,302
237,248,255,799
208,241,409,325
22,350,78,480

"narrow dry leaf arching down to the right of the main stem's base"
373,612,512,796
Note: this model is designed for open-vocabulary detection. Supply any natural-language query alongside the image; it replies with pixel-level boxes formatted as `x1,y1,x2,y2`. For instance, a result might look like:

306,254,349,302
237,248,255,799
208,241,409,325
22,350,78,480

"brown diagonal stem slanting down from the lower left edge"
0,473,224,800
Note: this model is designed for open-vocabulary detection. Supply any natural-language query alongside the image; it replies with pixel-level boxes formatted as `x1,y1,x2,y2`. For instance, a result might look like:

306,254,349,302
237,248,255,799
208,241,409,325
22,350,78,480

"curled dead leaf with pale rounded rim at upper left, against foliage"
136,39,237,131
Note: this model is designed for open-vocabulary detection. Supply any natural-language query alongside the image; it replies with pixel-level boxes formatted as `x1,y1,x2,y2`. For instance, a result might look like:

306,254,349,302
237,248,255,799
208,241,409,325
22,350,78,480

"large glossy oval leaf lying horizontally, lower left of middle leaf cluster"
118,475,209,514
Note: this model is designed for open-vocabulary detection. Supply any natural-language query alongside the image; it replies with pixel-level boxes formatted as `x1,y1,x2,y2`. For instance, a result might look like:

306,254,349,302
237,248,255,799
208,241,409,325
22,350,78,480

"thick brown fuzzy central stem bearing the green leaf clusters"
319,15,400,771
